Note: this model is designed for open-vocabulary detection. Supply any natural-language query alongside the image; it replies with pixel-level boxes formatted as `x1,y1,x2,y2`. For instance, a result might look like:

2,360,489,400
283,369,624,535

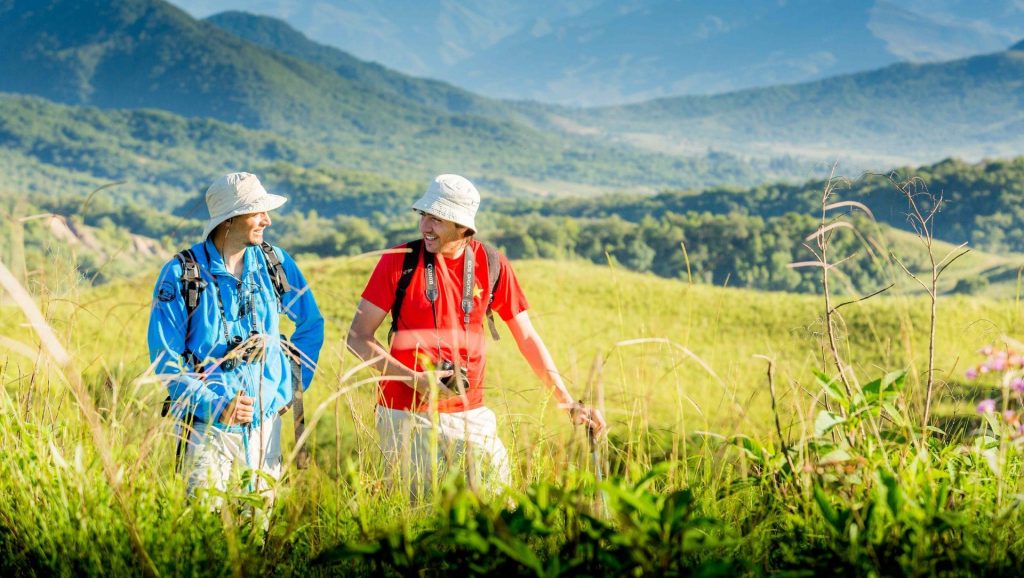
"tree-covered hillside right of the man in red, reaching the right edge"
483,158,1024,295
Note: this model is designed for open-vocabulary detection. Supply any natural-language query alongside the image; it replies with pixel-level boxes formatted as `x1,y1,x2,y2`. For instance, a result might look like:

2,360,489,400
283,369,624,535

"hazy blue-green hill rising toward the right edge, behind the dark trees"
561,42,1024,163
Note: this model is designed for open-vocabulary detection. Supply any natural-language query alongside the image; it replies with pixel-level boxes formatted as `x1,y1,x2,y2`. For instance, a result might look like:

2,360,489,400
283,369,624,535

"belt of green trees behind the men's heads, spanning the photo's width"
9,152,1024,295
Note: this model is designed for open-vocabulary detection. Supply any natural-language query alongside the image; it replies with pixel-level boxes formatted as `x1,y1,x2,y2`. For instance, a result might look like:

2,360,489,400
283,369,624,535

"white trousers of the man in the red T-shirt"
377,406,512,500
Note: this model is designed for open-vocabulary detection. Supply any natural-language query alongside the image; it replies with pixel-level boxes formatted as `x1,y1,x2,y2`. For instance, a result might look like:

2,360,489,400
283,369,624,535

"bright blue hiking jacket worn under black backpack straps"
148,236,324,430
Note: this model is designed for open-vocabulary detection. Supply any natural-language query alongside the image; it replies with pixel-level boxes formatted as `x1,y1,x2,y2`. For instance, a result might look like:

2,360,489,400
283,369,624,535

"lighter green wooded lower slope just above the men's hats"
0,89,790,210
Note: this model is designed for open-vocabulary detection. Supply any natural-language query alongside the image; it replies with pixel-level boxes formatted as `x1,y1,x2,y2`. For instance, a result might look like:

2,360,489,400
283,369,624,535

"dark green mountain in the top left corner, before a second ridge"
0,0,515,138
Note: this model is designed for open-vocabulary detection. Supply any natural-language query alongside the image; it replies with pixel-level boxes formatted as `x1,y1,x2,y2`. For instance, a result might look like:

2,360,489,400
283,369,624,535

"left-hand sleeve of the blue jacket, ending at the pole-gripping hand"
147,259,230,421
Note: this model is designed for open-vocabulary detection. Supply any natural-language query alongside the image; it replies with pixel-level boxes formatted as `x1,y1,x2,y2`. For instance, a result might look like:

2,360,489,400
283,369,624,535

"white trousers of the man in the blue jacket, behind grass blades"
184,415,282,509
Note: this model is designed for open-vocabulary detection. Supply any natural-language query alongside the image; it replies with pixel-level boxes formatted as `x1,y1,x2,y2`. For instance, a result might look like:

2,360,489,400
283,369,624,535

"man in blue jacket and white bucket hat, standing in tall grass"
148,172,324,504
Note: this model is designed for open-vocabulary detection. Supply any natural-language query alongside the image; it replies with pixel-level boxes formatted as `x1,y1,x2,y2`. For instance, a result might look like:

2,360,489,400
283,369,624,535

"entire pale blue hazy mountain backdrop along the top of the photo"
169,0,1024,106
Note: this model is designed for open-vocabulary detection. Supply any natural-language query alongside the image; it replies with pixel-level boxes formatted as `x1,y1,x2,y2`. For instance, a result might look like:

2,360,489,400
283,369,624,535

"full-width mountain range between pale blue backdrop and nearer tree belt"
0,0,1024,208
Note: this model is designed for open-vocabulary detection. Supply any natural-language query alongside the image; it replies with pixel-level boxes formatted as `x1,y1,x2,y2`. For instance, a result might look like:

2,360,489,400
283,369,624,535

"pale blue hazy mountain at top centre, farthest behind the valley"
455,0,897,105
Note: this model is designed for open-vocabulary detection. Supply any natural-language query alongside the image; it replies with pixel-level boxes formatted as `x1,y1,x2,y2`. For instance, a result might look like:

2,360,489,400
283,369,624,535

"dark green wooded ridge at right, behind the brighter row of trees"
501,157,1024,253
